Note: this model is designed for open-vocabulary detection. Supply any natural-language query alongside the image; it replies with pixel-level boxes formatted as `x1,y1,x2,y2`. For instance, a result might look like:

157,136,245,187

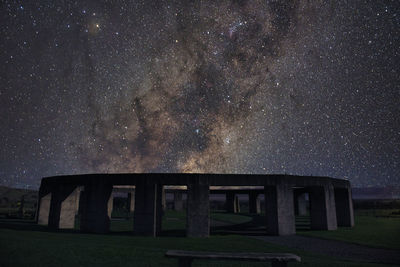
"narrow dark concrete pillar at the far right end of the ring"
335,188,354,227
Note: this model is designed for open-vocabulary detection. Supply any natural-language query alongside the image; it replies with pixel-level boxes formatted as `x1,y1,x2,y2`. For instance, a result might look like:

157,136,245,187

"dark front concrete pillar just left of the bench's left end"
133,179,162,236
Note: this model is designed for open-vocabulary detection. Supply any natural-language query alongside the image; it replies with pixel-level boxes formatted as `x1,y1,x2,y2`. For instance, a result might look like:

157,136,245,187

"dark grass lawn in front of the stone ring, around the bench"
0,229,394,267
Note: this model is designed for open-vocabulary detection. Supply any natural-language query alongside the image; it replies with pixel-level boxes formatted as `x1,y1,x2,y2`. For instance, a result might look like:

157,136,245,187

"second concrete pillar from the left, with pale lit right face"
48,184,78,229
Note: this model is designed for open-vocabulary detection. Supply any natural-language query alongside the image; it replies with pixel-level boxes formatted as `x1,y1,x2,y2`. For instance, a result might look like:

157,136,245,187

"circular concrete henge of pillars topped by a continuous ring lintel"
36,173,354,237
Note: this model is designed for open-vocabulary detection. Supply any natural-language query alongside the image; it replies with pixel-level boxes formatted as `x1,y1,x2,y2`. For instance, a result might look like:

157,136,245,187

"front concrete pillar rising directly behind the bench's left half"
186,176,210,237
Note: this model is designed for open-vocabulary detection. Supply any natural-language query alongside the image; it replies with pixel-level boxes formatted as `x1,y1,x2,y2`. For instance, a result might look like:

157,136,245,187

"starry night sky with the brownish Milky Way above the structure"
0,0,400,188
